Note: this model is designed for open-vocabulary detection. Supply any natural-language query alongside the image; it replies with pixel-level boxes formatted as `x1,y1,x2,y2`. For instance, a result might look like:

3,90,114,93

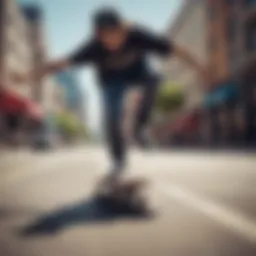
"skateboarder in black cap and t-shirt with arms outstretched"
13,9,208,186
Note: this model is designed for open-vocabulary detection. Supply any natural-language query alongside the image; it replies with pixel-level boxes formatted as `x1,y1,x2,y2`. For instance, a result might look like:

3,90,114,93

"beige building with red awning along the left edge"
0,0,53,147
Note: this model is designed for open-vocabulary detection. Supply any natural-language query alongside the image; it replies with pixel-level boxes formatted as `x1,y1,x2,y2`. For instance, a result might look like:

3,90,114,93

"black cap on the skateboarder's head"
94,8,122,30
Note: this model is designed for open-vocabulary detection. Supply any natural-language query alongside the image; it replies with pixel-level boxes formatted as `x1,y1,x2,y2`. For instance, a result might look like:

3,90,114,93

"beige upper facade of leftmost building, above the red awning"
0,0,33,98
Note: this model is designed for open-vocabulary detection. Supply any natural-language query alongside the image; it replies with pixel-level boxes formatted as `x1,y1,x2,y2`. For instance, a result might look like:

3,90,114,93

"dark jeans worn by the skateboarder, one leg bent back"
103,76,159,165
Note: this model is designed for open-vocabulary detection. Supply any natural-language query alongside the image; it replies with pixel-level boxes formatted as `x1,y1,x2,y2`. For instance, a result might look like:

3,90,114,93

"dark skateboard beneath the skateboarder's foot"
95,178,150,214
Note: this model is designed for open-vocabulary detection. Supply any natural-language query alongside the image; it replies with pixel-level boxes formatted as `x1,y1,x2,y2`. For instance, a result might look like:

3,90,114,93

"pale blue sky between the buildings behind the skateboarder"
18,0,182,136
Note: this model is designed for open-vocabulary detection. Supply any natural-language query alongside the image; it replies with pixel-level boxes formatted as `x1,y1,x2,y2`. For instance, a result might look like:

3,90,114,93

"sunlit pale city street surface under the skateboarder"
0,146,256,256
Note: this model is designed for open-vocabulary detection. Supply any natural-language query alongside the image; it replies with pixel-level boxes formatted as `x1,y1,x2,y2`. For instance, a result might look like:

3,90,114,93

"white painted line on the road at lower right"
158,184,256,244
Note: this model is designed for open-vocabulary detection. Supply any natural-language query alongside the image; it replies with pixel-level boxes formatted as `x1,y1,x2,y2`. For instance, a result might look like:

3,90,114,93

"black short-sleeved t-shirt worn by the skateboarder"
69,27,172,84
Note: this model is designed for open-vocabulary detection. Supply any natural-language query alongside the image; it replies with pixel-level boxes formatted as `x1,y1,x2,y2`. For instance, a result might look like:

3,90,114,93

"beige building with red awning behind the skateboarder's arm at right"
154,0,208,143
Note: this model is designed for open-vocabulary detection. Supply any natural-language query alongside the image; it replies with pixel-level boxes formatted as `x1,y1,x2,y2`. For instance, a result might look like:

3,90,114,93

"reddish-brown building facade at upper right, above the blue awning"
207,0,256,80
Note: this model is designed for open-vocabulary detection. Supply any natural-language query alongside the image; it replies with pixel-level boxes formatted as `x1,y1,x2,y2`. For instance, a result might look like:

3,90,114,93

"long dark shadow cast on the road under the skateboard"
19,196,153,236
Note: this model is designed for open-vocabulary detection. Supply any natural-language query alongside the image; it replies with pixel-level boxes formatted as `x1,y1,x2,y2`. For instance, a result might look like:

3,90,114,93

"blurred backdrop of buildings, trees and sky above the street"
0,0,256,147
